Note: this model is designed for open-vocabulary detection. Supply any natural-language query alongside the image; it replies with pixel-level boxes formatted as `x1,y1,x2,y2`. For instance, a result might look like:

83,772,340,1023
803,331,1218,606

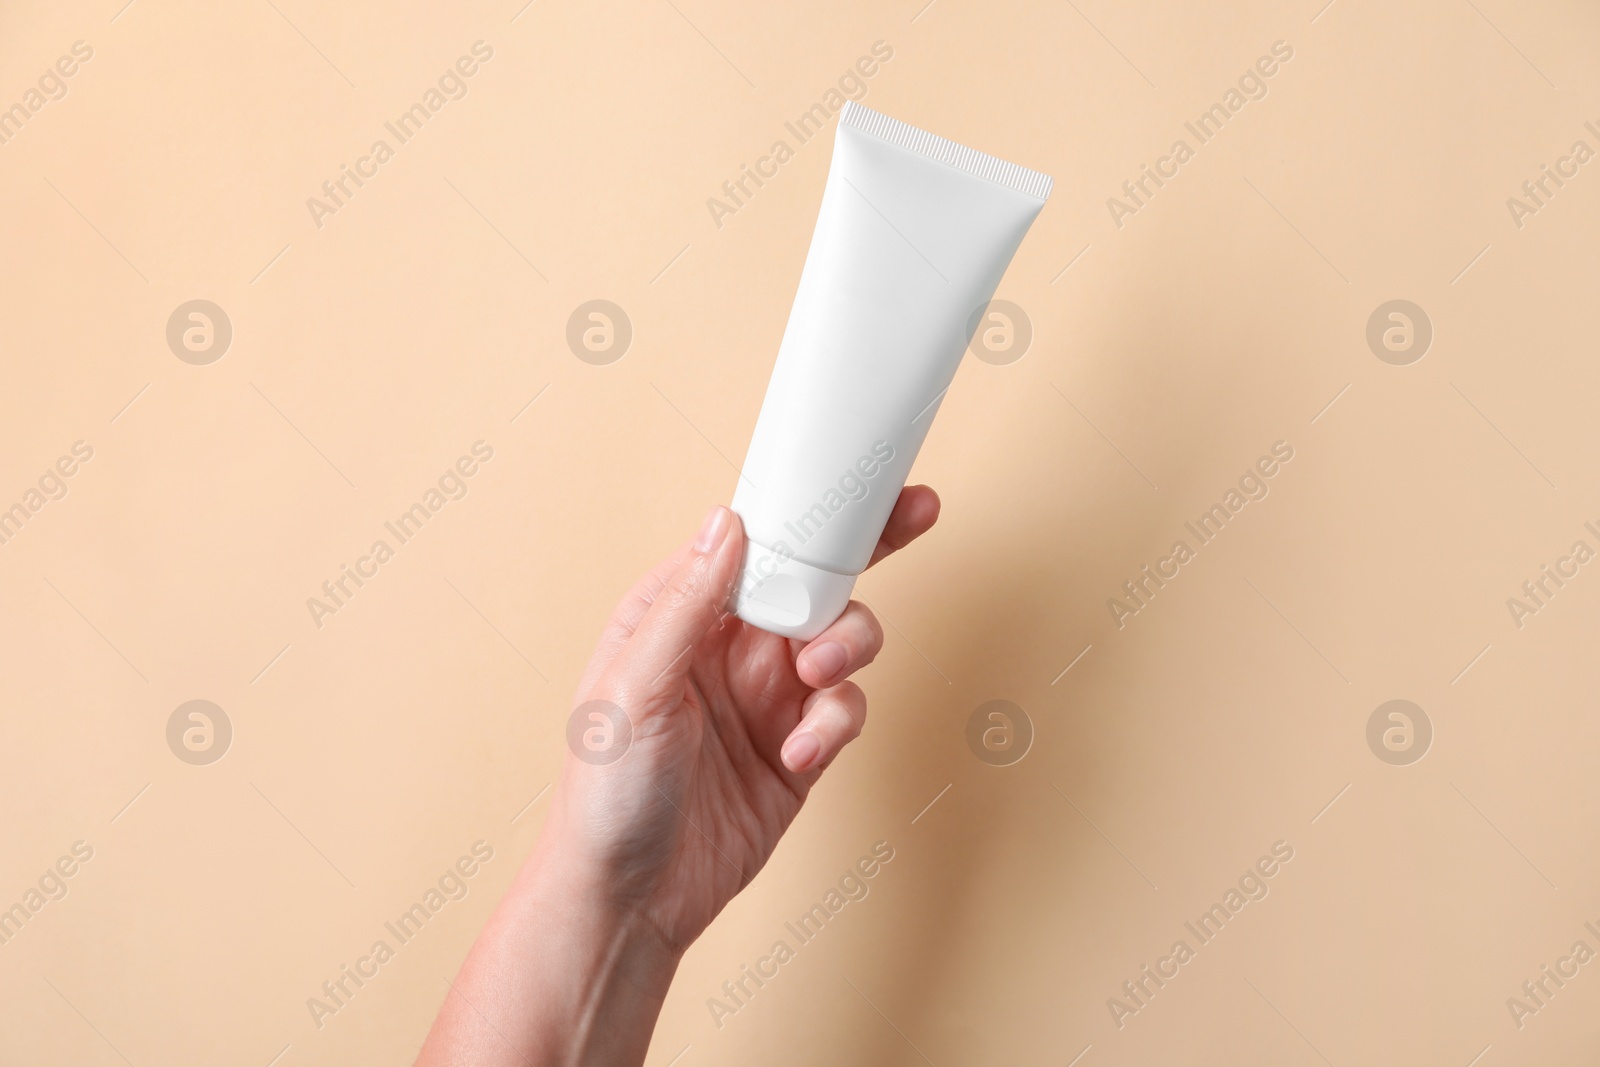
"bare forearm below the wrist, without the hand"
418,825,677,1067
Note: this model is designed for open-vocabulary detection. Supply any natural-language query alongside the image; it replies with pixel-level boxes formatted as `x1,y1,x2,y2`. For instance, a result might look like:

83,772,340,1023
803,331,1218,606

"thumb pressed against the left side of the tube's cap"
619,506,744,693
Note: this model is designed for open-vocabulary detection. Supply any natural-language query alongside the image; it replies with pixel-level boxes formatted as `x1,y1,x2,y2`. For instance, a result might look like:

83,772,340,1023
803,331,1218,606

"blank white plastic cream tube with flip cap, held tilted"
733,101,1050,640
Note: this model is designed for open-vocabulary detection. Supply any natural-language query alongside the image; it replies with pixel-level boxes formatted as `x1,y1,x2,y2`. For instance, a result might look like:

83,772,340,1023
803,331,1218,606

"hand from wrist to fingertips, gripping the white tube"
546,486,939,953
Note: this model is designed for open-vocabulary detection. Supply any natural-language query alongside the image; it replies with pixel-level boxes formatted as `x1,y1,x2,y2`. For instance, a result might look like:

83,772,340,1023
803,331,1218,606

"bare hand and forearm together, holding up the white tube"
416,485,939,1067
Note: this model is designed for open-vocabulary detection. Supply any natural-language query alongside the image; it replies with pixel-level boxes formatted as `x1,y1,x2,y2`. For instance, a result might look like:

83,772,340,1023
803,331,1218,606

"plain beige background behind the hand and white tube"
0,0,1600,1067
